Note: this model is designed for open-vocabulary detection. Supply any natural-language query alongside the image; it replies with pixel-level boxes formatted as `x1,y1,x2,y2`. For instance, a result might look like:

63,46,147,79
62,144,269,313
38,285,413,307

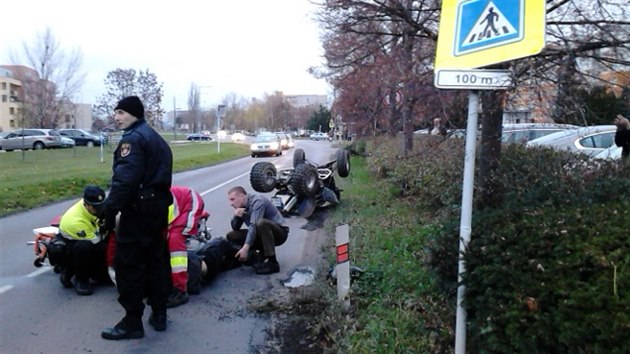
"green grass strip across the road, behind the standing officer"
0,142,249,216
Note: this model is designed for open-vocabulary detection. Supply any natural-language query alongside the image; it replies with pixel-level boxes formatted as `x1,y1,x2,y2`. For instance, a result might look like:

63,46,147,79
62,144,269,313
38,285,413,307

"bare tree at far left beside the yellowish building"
11,28,85,128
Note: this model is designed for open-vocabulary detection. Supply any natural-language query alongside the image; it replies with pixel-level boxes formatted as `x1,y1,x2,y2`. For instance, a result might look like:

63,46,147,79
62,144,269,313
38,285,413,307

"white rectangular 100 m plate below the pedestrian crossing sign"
435,69,512,90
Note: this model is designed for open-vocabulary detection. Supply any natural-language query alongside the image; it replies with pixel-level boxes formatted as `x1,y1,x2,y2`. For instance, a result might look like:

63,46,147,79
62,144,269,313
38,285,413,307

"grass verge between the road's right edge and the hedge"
318,158,453,353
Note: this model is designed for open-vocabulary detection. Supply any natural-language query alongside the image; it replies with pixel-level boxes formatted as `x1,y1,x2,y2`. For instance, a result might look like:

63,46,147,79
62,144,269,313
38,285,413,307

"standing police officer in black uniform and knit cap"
101,96,173,339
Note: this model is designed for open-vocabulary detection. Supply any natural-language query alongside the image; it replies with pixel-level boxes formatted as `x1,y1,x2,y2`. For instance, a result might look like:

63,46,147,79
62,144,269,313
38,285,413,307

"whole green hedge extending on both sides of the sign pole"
364,136,630,353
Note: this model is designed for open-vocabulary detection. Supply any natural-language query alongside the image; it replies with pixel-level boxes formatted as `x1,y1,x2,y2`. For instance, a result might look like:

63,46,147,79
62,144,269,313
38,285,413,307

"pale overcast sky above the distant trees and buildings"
0,0,330,110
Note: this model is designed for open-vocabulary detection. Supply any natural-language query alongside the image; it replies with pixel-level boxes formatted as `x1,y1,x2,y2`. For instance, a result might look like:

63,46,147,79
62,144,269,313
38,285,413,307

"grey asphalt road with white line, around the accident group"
0,140,334,353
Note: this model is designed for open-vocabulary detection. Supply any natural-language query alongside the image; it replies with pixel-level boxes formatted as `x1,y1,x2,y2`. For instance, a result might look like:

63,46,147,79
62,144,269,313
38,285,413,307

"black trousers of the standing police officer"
115,200,171,321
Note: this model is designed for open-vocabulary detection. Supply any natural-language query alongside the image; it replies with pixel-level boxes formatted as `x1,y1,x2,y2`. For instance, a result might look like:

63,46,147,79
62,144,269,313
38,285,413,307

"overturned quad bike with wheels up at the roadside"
249,148,350,218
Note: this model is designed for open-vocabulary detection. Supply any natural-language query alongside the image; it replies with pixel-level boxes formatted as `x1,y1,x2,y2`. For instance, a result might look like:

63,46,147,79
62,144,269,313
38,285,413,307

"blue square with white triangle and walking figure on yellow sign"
454,0,525,56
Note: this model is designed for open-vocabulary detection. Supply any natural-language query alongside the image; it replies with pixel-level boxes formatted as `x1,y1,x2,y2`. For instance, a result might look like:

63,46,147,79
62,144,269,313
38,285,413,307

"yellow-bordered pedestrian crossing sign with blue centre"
435,0,545,69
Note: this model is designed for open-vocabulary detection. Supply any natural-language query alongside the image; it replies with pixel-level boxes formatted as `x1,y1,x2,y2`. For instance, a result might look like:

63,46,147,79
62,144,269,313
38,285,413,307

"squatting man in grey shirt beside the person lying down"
226,186,289,274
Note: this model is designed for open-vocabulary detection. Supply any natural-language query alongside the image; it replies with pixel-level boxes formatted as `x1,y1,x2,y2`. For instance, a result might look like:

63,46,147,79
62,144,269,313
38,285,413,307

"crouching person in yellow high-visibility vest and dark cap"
58,185,109,296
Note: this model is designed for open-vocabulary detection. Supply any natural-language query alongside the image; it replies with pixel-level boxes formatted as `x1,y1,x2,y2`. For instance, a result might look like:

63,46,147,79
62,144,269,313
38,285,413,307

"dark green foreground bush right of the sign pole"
464,200,630,353
